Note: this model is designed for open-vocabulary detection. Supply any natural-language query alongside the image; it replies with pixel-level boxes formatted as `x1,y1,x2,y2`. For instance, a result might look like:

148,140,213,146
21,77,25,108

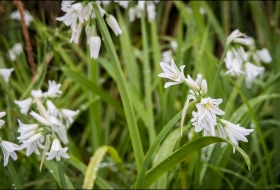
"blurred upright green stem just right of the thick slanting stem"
141,17,156,144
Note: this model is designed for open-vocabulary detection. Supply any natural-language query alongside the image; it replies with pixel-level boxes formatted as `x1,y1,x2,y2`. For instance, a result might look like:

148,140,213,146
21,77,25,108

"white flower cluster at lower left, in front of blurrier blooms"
17,98,70,161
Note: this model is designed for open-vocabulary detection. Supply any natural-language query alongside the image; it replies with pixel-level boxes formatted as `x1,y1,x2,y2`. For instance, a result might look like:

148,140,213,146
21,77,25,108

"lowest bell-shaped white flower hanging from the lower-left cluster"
46,139,70,161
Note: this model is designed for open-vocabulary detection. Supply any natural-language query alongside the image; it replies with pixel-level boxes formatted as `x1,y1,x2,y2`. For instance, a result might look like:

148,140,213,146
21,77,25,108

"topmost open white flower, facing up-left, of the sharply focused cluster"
158,59,185,88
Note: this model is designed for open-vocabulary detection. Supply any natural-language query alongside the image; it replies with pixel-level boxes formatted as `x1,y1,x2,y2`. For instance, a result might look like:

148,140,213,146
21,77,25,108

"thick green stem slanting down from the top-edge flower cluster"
93,3,144,171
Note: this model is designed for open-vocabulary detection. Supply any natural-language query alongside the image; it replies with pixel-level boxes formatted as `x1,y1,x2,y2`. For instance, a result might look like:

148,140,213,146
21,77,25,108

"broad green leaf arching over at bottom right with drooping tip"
135,137,251,188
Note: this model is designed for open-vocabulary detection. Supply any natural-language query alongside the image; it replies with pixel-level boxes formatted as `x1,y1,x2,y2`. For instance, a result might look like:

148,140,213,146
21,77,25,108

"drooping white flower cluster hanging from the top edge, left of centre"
56,0,125,59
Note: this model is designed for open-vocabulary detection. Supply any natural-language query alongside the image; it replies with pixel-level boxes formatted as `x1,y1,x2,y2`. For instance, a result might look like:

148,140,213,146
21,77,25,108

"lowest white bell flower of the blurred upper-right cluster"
245,62,264,88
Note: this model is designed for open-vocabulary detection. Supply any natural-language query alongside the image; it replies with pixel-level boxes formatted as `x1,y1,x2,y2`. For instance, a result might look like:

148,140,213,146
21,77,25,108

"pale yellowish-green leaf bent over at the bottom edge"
83,146,122,189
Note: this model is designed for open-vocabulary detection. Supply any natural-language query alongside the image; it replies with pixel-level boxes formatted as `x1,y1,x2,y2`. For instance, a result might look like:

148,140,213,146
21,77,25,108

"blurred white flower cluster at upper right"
224,29,272,88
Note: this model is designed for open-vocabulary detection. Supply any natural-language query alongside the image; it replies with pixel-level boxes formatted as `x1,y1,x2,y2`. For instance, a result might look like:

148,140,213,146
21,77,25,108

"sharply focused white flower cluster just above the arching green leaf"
159,60,253,152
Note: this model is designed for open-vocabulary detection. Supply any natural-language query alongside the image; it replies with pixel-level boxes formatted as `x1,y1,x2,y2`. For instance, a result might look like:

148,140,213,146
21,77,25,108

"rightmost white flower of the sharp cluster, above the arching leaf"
218,119,254,153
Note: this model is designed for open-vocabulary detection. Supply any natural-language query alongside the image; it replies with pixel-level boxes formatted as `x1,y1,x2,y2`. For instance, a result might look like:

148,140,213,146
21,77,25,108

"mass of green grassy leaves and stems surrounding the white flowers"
0,1,280,189
